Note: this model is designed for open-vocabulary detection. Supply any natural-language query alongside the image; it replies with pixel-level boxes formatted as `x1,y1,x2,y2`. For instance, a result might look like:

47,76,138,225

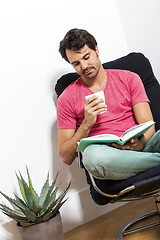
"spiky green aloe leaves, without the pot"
0,168,70,226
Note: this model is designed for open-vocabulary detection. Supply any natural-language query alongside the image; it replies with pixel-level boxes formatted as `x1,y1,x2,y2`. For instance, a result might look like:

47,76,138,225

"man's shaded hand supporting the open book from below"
112,136,146,151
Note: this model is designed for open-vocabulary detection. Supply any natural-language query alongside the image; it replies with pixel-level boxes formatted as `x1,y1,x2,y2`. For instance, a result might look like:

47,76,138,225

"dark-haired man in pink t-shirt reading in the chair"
57,29,160,180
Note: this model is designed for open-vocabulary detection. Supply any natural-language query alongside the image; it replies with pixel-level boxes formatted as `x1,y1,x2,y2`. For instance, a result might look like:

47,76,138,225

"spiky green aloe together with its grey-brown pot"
0,168,70,240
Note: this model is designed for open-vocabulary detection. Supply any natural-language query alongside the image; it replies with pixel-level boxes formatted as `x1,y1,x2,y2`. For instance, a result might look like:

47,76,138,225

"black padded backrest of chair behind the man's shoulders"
55,53,160,130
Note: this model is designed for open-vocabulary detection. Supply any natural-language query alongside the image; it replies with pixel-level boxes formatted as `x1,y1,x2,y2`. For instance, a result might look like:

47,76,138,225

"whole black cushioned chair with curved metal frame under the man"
55,53,160,240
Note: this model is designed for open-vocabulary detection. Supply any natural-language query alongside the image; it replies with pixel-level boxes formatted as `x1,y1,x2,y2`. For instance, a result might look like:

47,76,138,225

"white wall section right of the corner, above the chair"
115,0,160,81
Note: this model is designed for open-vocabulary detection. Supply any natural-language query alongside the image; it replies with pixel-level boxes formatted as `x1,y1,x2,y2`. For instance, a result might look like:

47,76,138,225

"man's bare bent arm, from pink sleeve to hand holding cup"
58,96,106,165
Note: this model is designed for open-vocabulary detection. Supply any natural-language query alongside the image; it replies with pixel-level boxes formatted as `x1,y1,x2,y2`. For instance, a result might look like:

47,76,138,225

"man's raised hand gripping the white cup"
84,96,107,127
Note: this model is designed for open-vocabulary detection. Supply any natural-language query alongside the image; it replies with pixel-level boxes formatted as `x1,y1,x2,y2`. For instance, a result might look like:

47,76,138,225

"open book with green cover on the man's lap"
76,120,155,152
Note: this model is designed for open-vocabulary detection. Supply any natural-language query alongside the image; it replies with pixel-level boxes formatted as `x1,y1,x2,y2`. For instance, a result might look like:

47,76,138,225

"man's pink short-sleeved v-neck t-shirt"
57,69,149,136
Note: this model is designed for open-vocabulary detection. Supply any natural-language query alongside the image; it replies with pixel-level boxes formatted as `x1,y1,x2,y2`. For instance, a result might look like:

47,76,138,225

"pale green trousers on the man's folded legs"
83,131,160,180
